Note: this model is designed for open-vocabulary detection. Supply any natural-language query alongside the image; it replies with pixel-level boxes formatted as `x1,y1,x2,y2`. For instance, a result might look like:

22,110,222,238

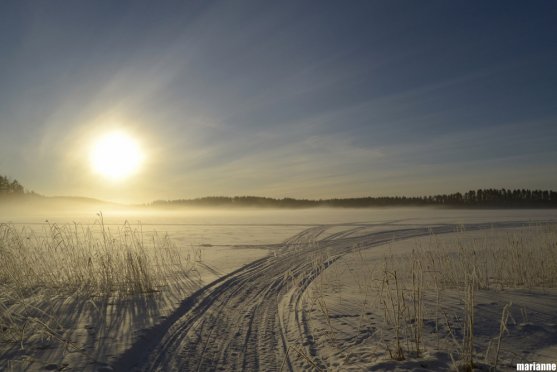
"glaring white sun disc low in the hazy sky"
90,132,143,181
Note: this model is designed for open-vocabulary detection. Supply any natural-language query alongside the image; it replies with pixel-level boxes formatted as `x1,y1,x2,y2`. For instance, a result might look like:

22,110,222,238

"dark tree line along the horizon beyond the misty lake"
0,176,557,208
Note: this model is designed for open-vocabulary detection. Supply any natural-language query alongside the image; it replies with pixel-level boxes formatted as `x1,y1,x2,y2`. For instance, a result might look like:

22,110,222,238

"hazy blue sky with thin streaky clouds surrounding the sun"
0,0,557,202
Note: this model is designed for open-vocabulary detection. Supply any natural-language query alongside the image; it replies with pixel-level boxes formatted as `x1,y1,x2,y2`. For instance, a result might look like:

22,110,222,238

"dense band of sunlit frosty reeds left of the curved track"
0,215,200,295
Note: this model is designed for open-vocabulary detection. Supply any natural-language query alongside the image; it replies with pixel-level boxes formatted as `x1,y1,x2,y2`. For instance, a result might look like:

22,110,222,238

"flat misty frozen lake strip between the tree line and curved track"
0,207,557,246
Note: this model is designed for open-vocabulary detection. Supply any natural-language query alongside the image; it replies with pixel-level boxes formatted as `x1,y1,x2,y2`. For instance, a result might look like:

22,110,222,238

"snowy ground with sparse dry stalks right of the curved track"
291,225,557,371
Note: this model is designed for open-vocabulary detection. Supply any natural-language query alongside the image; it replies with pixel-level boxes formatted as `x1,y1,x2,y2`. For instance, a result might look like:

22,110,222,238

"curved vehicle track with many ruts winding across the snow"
113,222,524,371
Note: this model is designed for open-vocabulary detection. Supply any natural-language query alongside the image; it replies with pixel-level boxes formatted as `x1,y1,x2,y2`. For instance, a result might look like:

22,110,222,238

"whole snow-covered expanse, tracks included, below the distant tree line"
0,208,557,371
